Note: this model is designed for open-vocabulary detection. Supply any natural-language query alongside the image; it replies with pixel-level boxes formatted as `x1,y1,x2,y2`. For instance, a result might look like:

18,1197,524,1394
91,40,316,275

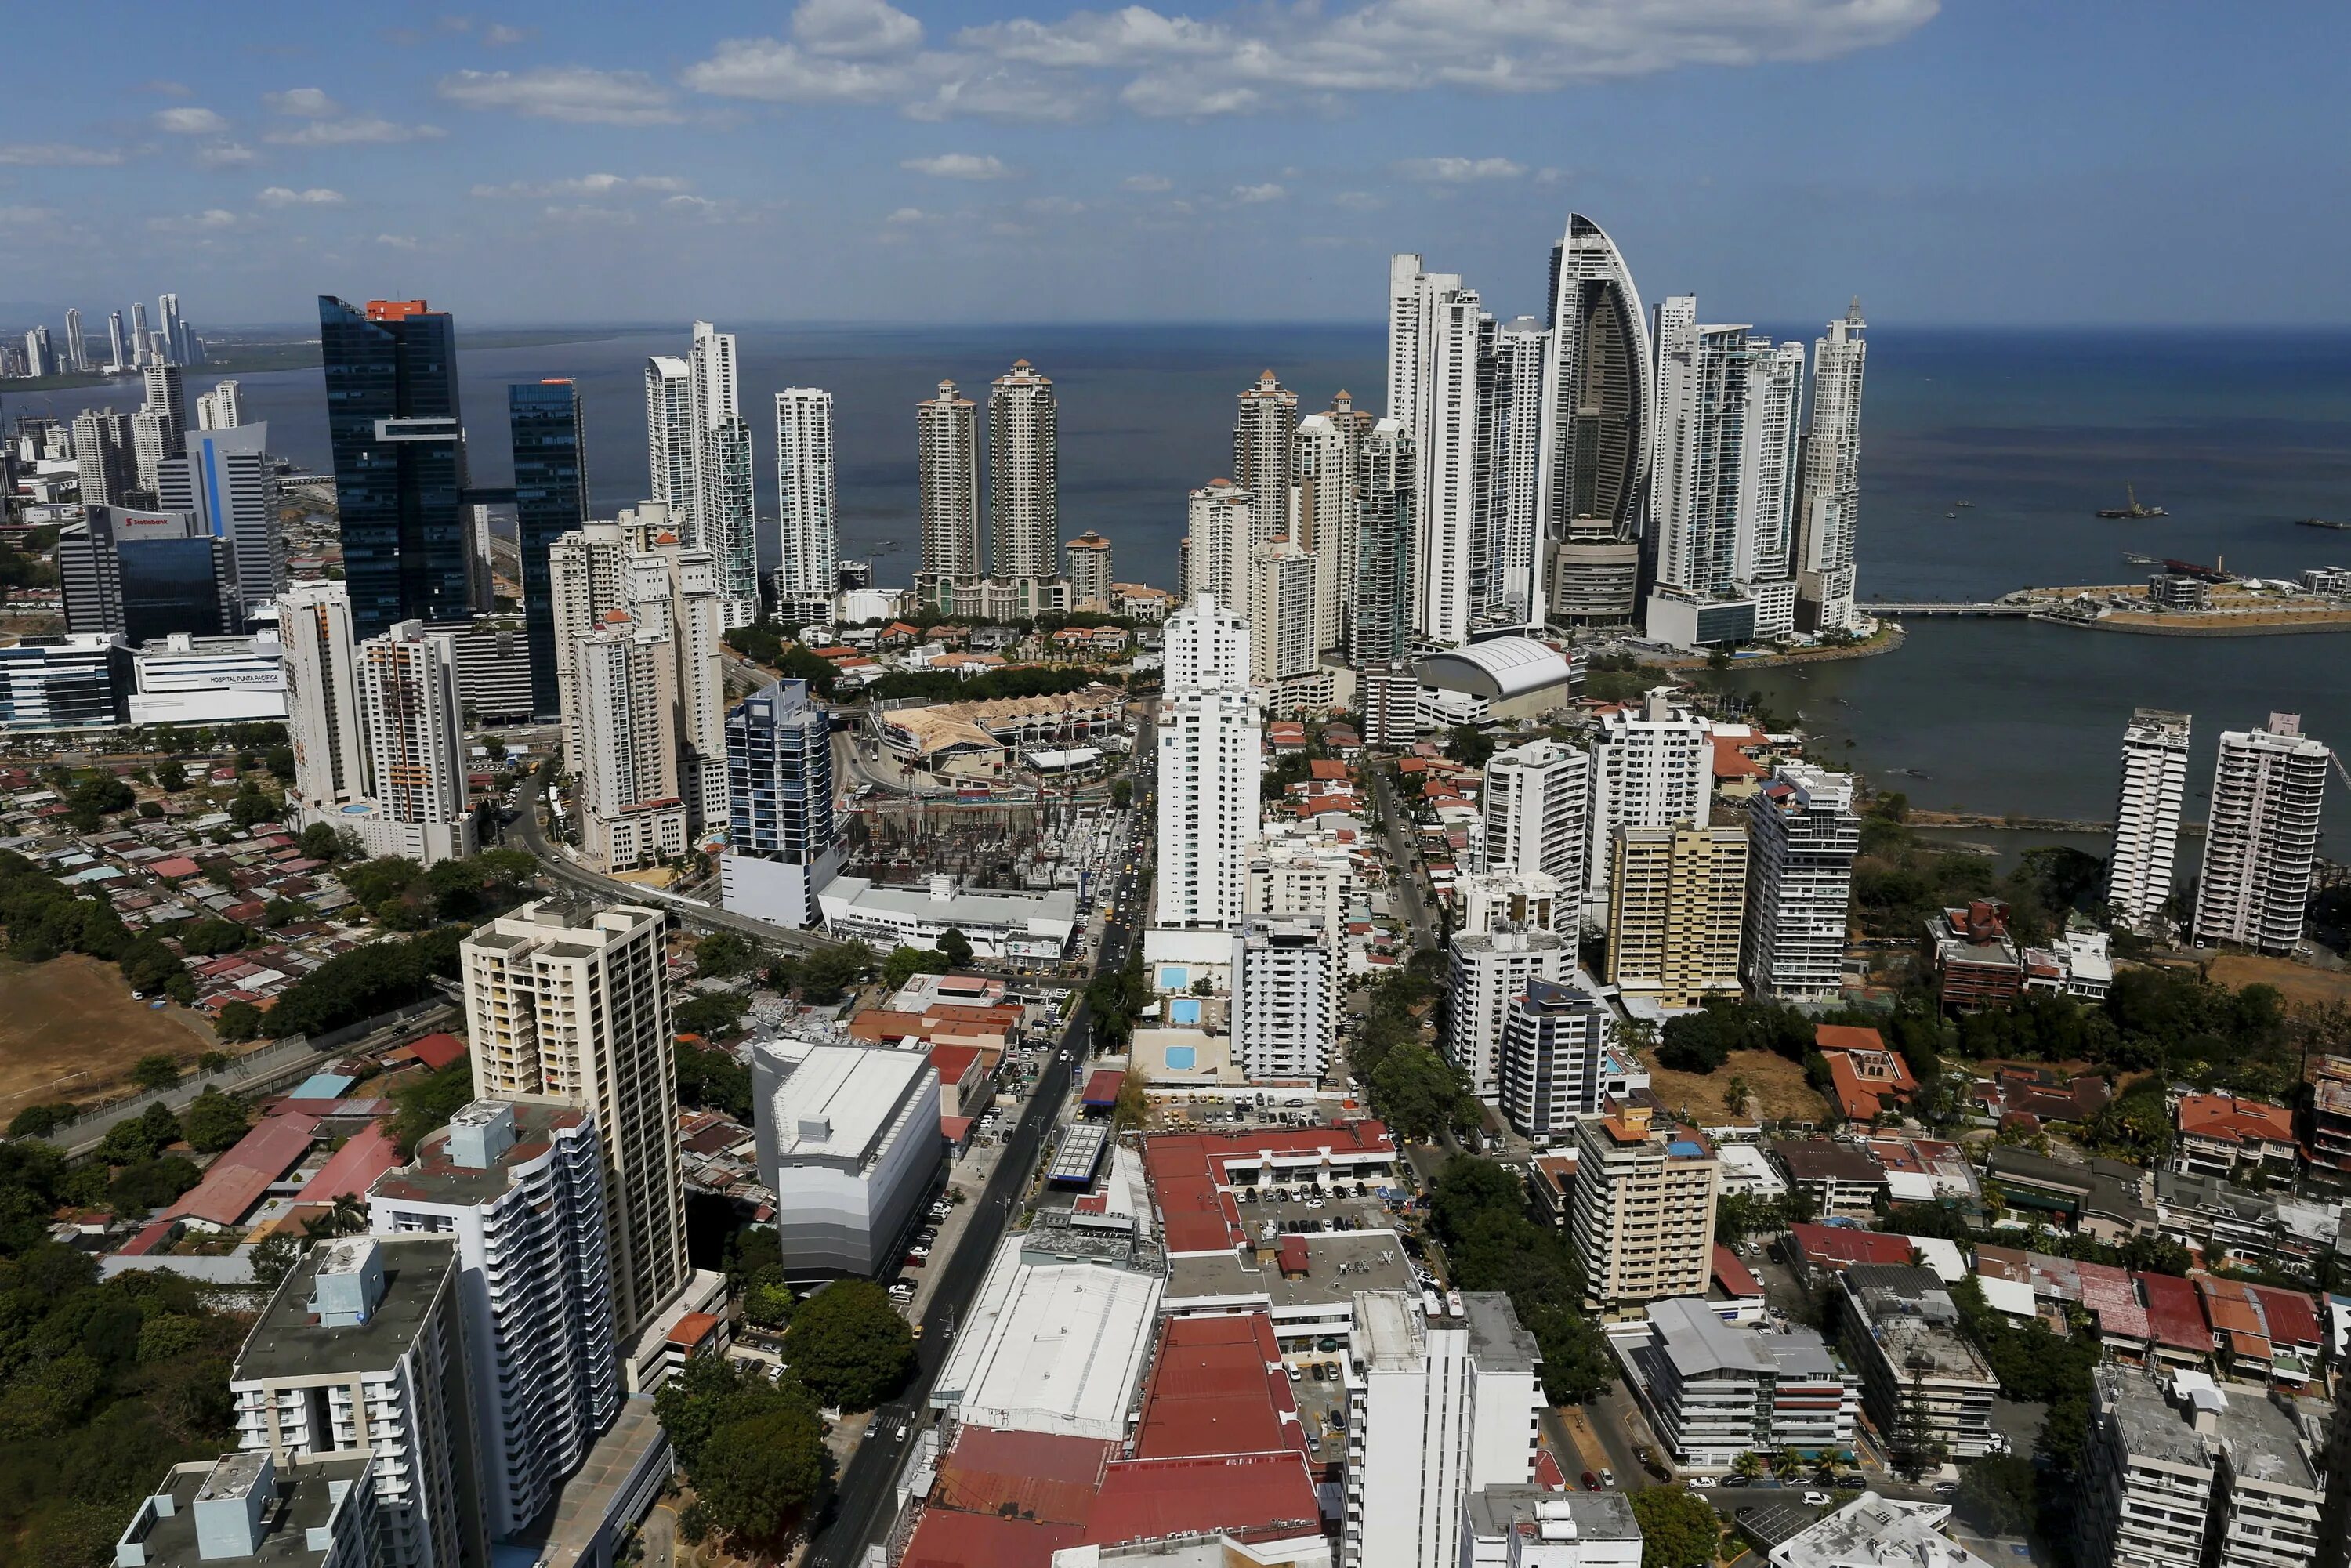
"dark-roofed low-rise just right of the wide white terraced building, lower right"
1824,1269,2001,1462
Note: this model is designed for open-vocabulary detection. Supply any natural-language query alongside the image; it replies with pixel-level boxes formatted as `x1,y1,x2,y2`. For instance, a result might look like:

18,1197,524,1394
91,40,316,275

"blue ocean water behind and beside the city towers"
32,320,2351,832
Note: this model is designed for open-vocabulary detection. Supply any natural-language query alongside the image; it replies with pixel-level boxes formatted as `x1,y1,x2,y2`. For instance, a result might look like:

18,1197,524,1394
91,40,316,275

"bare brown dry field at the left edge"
0,952,212,1110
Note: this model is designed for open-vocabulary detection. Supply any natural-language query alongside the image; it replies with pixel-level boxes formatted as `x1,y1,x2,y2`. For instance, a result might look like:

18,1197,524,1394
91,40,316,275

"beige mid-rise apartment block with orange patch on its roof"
1568,1100,1721,1309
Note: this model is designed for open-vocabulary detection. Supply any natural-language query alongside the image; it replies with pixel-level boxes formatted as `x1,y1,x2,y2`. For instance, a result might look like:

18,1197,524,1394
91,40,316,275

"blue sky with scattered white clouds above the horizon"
0,0,2351,331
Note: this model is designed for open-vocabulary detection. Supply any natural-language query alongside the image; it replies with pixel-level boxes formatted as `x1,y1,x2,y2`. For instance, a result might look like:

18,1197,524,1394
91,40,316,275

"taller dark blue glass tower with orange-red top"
317,294,473,637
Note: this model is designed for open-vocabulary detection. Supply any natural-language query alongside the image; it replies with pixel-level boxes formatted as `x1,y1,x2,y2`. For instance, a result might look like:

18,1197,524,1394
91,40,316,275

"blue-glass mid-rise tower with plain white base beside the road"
719,679,844,929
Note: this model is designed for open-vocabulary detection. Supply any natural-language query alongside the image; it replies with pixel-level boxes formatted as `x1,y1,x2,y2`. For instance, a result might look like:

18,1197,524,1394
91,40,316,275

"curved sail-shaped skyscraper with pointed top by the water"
1535,212,1655,625
